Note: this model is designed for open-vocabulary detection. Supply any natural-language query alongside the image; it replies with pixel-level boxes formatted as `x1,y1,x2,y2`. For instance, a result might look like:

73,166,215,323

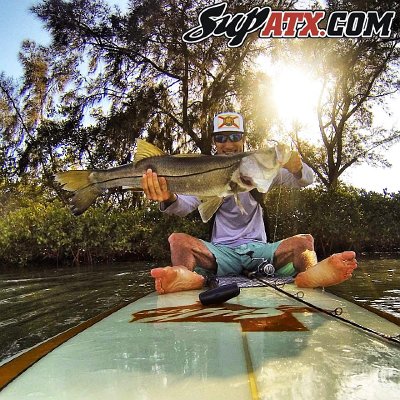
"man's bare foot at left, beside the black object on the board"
150,266,204,294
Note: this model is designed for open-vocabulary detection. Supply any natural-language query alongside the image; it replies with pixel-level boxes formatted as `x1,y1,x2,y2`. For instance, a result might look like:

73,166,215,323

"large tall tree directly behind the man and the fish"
26,0,295,163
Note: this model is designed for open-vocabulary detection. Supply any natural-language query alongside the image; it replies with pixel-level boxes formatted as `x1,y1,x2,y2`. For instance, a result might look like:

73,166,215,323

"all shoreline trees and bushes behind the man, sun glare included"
0,0,400,266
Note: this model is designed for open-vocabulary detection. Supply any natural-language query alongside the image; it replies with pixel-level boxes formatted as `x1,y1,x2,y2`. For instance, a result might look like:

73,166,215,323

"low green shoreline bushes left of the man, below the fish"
0,192,207,265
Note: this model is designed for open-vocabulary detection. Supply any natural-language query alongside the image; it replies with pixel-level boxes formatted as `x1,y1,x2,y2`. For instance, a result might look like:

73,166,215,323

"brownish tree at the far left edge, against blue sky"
0,41,75,183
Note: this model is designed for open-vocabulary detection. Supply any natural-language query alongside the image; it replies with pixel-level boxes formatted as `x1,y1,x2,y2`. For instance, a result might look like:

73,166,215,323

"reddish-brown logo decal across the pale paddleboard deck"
130,303,315,332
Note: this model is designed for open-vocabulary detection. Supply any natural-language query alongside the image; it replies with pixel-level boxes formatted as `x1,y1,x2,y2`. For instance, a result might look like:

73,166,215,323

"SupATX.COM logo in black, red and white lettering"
182,2,396,47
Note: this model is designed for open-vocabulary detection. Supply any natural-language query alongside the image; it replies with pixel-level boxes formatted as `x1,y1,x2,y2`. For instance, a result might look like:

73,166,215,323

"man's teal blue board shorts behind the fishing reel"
195,240,297,277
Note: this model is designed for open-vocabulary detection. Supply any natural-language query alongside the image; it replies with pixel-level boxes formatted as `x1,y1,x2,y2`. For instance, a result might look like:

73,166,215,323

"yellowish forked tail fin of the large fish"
55,170,102,215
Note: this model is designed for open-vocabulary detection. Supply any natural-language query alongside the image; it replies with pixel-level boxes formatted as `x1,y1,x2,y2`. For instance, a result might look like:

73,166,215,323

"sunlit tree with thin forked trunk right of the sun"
287,1,400,188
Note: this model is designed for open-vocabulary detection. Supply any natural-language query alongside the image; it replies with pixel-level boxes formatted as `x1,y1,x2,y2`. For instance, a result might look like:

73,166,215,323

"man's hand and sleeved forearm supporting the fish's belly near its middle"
142,169,200,217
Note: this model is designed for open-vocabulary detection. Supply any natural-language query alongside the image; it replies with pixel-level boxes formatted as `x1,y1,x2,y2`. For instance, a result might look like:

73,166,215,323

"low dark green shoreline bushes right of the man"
265,186,400,256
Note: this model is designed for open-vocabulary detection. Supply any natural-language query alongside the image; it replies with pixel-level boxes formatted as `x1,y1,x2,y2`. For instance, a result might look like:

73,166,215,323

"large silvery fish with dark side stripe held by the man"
55,139,291,222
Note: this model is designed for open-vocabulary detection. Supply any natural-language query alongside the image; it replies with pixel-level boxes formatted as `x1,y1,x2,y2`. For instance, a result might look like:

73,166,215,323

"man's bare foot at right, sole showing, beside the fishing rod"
295,251,357,288
